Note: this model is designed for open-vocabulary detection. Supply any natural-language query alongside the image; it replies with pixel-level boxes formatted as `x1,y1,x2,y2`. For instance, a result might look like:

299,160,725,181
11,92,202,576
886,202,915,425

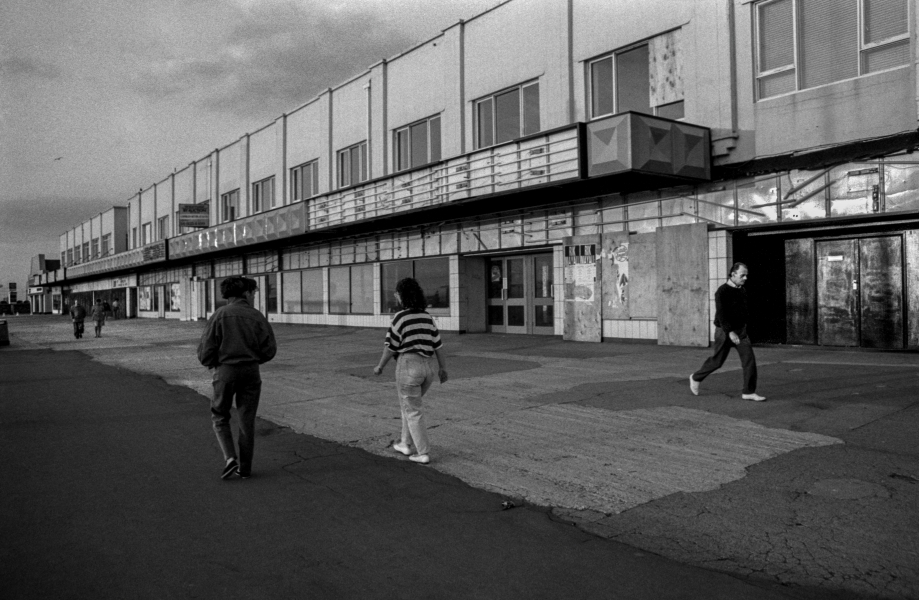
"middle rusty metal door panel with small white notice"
817,240,858,346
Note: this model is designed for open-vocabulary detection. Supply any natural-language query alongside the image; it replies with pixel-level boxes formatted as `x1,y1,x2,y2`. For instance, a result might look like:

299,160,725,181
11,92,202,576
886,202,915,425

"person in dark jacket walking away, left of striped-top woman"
198,276,277,479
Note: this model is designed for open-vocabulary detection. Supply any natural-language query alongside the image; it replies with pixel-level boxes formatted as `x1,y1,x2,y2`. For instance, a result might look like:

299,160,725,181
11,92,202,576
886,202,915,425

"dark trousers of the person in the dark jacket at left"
211,362,262,475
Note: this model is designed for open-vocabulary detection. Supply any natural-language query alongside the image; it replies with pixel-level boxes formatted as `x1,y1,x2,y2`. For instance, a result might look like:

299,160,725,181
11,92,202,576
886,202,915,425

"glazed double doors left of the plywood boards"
488,253,555,335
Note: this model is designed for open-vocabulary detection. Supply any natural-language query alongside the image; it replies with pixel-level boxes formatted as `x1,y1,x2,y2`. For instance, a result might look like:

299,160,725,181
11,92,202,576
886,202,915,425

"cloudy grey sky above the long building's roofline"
0,0,501,300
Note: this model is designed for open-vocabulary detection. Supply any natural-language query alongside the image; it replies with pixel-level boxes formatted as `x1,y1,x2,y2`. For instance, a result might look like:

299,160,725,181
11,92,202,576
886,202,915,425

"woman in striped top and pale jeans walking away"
373,277,447,465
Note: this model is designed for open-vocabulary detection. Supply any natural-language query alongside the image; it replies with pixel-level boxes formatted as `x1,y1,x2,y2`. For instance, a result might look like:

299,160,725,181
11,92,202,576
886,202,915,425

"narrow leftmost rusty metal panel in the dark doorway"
785,239,817,344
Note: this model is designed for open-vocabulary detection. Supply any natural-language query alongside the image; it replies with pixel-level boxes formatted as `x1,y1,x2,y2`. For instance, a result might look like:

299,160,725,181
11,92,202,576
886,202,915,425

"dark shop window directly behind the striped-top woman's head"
380,258,450,315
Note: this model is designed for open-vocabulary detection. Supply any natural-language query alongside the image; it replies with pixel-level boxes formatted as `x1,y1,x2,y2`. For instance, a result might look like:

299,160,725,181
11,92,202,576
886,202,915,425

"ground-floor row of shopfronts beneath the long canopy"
53,211,919,349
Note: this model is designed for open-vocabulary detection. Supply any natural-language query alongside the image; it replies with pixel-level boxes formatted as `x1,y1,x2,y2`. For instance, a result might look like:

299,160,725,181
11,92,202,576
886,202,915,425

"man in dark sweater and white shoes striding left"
689,263,766,402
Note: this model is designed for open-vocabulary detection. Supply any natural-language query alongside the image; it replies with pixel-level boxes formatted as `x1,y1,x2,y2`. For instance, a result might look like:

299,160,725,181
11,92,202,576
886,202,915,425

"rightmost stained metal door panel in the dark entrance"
859,236,903,348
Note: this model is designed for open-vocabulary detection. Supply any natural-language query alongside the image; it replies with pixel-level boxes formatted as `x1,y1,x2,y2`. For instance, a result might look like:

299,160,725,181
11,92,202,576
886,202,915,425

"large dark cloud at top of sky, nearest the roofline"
134,3,420,119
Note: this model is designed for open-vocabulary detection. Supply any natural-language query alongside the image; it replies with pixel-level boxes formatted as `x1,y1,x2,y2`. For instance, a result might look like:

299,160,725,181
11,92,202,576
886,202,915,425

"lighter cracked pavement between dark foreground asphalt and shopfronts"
0,316,919,598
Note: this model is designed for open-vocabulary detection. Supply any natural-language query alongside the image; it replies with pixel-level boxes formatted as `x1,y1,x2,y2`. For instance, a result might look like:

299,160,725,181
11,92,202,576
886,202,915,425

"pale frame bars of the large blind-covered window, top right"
752,0,912,102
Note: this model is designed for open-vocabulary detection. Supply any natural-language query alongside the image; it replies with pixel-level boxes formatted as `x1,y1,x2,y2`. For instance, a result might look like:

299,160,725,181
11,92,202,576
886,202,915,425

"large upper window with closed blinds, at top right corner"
755,0,910,99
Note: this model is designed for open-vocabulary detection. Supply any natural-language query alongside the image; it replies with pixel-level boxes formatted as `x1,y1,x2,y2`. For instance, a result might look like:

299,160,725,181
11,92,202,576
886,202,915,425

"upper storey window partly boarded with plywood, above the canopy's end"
588,30,684,119
